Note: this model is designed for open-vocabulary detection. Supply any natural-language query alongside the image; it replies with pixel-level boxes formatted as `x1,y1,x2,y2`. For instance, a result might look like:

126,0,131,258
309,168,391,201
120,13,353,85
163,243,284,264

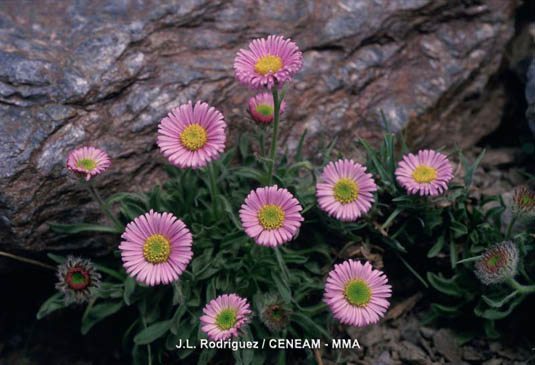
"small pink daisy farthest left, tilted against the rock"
67,147,111,181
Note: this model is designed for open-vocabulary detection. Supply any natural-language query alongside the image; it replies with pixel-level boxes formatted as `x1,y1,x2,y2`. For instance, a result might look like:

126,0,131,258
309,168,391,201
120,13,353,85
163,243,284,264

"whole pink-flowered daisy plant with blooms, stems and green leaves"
30,32,532,364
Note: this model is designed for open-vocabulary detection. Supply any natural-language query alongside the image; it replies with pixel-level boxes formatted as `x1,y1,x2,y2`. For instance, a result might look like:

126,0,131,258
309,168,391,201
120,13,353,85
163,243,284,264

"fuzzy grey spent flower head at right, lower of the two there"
475,241,518,285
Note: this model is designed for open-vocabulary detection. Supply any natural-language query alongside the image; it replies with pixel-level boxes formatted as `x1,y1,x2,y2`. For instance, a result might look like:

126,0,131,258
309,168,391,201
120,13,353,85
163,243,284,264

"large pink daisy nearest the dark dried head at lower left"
119,209,193,286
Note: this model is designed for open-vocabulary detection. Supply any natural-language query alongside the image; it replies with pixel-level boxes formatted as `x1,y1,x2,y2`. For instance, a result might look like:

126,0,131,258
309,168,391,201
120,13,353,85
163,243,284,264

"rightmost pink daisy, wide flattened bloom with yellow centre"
395,150,453,196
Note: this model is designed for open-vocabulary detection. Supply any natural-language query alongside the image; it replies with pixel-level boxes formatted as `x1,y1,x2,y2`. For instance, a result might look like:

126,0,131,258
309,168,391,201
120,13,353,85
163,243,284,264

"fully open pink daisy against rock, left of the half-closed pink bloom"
158,101,226,168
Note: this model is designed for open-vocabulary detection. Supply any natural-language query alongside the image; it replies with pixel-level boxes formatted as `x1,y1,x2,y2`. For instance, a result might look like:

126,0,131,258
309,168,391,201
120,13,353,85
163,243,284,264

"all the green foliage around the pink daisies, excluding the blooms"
38,132,533,364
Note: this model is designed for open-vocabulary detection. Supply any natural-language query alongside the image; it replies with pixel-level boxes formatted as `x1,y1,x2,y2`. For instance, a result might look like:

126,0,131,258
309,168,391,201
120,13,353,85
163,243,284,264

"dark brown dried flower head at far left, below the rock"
56,256,100,304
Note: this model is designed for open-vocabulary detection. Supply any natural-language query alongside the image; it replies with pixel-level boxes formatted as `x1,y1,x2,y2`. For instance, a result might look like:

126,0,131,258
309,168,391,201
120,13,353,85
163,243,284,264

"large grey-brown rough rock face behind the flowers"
0,0,521,251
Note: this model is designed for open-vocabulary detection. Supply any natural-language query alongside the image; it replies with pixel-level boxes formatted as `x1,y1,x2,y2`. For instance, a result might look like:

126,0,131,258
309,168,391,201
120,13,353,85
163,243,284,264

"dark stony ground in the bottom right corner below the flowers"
330,312,533,365
